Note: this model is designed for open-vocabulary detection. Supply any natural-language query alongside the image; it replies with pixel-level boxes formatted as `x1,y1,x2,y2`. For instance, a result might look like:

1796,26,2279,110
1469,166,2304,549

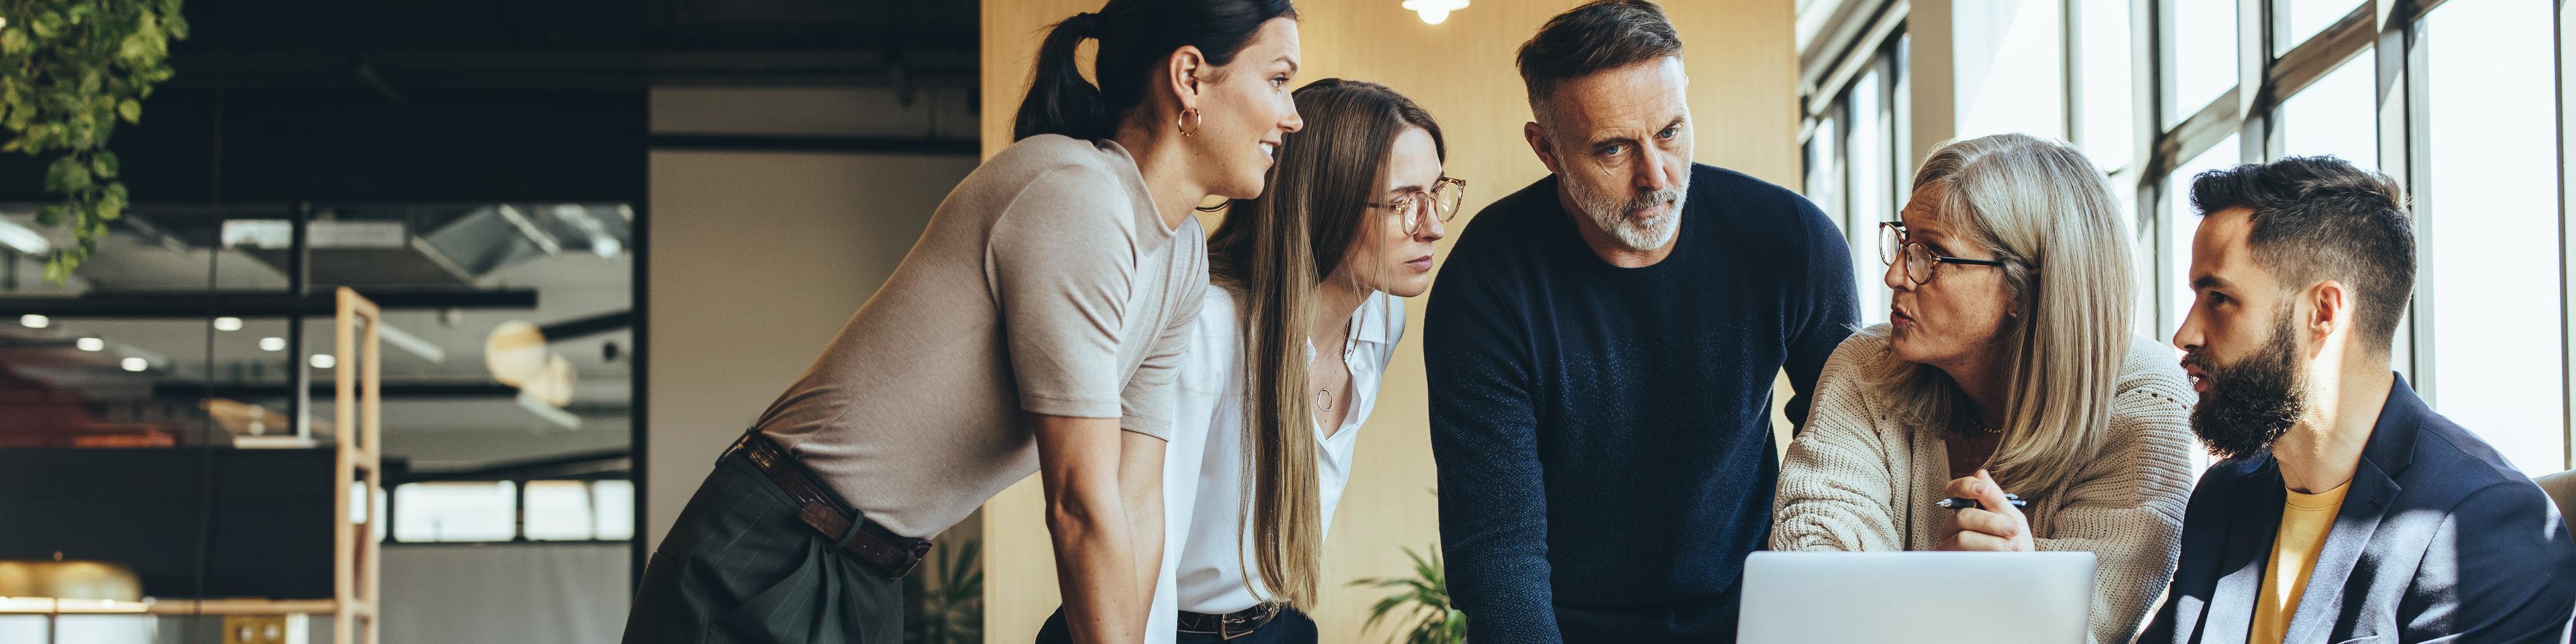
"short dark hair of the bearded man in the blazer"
2192,157,2416,347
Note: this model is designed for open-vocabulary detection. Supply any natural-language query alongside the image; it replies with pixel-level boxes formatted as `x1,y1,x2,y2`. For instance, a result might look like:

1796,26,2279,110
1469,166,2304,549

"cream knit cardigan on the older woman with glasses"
1770,325,2198,644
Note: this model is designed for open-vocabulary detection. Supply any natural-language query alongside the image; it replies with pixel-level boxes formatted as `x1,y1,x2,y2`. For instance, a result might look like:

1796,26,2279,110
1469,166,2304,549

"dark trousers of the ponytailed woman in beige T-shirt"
626,456,904,644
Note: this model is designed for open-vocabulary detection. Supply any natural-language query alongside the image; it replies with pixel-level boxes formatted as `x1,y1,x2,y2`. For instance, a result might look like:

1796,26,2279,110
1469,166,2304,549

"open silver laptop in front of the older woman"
1736,551,2094,644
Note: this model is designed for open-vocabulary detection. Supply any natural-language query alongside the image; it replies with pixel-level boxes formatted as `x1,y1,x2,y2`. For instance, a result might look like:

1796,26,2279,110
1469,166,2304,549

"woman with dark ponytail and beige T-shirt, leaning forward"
626,0,1301,644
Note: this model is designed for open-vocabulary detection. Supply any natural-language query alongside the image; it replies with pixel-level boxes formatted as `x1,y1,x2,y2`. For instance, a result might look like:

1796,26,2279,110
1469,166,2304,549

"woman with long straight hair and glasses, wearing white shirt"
1040,77,1463,644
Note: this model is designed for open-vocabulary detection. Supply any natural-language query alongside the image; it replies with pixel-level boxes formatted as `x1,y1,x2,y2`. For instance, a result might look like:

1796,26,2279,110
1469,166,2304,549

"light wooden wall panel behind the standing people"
984,0,1801,641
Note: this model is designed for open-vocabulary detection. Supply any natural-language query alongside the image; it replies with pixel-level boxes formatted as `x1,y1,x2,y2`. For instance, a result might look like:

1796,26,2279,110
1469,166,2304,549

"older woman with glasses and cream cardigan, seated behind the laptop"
1770,134,2195,641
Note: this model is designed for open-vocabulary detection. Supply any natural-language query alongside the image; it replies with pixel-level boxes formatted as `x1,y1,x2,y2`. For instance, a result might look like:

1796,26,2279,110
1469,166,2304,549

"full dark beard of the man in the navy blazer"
2182,314,2308,459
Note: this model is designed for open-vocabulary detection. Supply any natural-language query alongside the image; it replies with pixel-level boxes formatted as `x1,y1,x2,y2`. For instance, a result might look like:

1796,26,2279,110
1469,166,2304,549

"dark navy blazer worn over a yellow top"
2138,376,2576,644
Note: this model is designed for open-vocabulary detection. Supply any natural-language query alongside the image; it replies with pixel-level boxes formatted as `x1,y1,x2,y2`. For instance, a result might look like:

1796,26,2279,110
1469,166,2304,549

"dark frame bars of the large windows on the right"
1801,0,2576,469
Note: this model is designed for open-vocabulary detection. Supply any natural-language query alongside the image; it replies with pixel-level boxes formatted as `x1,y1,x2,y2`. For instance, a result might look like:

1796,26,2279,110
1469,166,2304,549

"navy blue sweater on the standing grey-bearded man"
1422,165,1855,644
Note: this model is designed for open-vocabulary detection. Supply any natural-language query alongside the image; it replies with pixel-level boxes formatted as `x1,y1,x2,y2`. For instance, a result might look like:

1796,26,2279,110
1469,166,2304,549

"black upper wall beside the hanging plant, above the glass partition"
0,0,979,206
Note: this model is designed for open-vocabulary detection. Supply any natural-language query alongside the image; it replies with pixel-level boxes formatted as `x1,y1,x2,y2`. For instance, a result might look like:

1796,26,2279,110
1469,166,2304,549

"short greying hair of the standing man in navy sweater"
1520,0,1682,123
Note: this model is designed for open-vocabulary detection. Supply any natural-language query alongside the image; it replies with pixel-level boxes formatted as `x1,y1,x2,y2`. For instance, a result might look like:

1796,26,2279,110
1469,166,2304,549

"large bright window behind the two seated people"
1803,0,2576,474
